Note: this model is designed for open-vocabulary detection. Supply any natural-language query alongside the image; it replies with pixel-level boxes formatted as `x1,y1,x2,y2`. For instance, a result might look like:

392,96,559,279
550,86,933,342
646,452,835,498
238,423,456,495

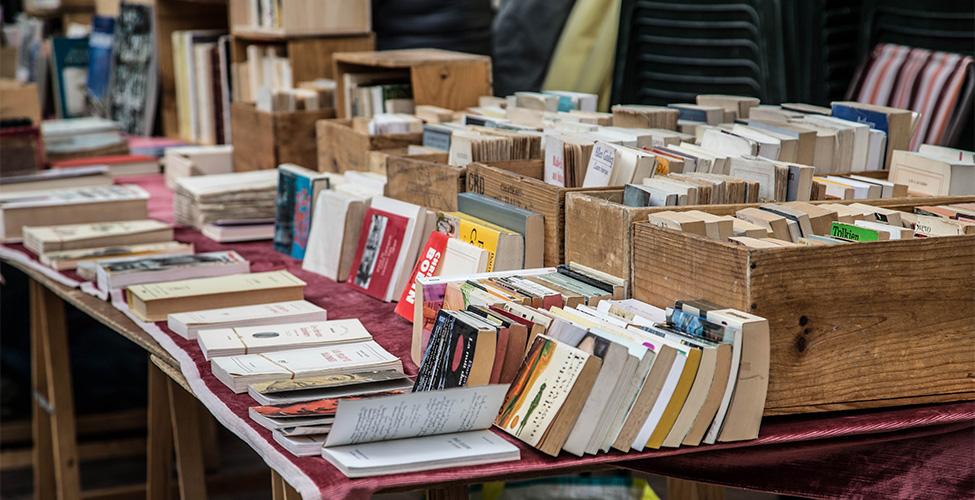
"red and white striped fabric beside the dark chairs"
856,44,973,150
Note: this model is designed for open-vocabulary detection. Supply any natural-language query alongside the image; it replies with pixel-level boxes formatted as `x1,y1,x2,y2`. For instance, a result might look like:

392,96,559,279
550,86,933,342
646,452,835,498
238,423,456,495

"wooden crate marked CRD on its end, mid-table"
467,160,612,266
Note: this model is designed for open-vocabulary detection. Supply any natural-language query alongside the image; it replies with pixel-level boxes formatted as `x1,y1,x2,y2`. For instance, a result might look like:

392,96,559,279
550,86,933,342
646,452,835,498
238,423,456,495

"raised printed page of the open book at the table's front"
325,384,508,446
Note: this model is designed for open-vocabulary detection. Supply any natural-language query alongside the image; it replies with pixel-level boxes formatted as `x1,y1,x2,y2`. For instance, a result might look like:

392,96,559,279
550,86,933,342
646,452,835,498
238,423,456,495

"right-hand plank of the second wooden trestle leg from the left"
167,379,207,500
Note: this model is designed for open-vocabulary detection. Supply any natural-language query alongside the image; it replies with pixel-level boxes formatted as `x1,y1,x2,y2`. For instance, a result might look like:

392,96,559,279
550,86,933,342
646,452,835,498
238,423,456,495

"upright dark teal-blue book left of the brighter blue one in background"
51,37,88,118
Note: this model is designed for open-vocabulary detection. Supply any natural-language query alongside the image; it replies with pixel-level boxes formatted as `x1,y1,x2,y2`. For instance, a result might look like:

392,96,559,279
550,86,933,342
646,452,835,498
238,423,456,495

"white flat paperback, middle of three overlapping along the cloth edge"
197,319,372,359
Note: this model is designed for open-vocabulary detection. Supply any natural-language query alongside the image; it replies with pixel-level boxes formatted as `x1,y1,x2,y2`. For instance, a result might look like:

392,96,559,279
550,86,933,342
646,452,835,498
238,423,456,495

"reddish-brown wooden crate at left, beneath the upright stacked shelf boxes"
230,103,335,171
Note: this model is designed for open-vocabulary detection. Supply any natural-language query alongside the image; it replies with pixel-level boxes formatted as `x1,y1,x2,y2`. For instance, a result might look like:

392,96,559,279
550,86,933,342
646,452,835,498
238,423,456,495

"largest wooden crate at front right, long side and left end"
632,197,975,415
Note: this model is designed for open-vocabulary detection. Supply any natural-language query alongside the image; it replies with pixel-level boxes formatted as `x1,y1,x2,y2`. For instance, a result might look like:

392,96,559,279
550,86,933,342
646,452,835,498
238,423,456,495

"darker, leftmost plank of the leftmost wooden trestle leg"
28,279,56,499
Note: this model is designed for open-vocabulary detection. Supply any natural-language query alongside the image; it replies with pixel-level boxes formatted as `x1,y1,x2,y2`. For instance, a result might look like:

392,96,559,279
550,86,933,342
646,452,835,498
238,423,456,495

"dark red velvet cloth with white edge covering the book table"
0,175,975,499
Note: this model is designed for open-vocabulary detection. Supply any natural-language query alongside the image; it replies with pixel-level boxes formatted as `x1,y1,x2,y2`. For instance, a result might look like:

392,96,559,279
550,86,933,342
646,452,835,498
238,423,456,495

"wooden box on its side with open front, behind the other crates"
333,49,493,118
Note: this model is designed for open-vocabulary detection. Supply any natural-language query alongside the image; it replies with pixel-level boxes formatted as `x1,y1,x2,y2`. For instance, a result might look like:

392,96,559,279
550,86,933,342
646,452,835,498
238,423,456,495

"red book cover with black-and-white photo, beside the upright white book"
349,208,409,300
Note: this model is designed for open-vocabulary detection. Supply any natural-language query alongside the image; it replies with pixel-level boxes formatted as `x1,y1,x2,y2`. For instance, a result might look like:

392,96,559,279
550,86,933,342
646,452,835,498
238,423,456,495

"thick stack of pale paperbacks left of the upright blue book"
173,170,278,233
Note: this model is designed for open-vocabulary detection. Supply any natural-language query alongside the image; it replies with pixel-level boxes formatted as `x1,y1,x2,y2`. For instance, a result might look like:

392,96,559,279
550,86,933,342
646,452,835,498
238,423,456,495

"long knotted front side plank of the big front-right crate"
750,236,975,412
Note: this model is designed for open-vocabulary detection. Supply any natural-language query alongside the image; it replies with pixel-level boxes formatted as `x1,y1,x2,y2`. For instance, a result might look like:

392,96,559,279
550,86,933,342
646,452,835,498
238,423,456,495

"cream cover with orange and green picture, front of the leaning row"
495,336,589,446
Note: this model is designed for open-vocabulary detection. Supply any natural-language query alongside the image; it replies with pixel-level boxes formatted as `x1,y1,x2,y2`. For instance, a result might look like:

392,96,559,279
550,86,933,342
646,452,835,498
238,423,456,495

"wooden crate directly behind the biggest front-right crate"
565,188,968,286
